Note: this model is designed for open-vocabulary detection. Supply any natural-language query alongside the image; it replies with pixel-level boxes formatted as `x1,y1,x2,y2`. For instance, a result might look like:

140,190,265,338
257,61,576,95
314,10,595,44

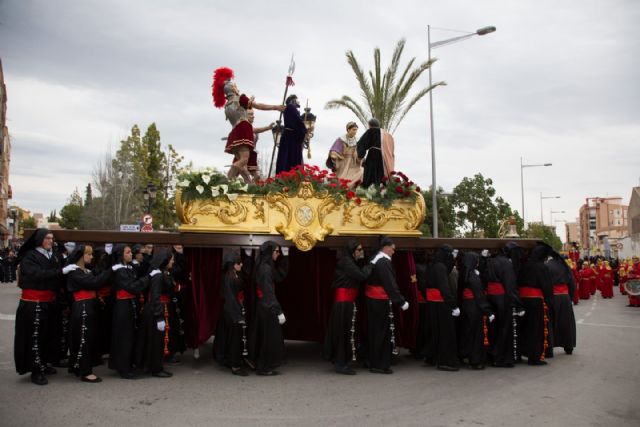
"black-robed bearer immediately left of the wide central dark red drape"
249,240,289,375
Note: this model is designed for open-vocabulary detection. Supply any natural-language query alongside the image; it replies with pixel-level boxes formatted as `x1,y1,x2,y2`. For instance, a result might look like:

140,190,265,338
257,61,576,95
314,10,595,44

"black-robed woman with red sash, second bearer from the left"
67,245,112,383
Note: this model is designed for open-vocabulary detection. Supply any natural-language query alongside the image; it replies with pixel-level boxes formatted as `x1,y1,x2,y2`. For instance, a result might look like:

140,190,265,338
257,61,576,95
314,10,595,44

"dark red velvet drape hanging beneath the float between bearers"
185,248,418,347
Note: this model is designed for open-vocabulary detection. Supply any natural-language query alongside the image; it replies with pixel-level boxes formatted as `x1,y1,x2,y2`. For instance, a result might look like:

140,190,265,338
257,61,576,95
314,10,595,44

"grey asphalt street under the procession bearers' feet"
0,284,640,427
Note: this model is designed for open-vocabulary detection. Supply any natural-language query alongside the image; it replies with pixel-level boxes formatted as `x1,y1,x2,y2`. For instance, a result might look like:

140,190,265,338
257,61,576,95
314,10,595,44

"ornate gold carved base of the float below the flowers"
176,182,426,251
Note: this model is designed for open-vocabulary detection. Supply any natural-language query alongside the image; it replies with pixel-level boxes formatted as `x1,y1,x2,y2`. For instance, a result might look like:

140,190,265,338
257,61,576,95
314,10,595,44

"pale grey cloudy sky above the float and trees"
0,0,640,237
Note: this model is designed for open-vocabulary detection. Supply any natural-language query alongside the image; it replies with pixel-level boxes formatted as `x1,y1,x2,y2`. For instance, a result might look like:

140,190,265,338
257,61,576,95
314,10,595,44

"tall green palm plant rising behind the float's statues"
325,39,446,133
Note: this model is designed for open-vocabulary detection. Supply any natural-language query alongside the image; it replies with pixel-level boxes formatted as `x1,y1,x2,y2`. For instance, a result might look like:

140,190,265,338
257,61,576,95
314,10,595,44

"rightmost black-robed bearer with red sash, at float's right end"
547,251,576,354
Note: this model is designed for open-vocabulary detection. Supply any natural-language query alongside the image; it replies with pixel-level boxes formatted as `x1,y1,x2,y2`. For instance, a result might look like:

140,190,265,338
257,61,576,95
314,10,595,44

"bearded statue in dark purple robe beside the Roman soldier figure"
276,95,307,174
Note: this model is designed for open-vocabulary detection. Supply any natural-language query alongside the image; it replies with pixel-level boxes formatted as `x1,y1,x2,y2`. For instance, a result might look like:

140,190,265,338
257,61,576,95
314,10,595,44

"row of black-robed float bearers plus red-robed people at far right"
15,229,640,385
